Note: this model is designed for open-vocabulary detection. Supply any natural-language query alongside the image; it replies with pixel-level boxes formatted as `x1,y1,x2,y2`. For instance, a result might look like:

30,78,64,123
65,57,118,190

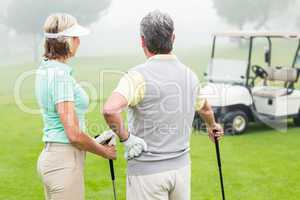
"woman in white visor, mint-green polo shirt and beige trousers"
36,14,116,200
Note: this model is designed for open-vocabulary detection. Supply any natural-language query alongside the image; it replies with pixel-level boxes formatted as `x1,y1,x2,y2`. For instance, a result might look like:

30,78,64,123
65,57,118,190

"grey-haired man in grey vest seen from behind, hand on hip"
103,11,223,200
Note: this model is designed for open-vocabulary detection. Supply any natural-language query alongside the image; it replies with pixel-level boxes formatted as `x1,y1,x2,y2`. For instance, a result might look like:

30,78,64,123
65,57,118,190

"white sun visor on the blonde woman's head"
44,24,90,39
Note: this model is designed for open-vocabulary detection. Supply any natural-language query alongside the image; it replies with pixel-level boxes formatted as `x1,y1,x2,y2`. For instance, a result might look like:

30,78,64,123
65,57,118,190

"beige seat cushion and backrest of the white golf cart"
253,67,299,98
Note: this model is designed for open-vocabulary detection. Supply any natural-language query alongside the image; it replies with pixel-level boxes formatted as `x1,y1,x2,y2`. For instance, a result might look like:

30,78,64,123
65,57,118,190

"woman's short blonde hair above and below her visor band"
44,13,77,60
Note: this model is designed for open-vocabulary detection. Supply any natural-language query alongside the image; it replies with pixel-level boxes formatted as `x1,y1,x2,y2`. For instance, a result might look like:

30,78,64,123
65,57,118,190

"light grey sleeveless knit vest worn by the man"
128,56,198,175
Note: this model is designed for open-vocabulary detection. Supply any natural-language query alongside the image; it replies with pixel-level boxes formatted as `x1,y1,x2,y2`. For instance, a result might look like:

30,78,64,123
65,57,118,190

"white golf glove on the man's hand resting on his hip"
122,134,147,160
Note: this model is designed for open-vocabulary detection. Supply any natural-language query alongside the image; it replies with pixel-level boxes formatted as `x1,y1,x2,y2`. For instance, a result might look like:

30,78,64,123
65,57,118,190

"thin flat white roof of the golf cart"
213,31,300,38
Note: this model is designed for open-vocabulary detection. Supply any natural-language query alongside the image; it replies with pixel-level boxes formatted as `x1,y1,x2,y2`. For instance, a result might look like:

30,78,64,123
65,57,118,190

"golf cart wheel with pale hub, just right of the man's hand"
223,111,249,135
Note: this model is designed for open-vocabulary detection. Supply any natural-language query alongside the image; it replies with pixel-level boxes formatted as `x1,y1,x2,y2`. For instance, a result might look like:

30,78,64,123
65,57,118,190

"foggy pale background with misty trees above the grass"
0,0,300,65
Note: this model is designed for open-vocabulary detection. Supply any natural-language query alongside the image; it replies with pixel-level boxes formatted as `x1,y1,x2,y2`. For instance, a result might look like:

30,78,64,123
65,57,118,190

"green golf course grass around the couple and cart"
0,44,300,200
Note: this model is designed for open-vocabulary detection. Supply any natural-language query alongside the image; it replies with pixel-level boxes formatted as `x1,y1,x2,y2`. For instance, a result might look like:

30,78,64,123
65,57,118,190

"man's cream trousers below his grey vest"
126,165,191,200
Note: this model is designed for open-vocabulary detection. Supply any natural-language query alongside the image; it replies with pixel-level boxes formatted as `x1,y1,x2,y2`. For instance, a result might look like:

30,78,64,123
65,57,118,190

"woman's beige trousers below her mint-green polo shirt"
37,143,85,200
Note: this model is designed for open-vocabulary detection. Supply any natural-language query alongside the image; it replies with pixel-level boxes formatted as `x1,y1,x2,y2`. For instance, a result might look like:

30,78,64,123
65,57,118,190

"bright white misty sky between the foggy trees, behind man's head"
83,0,226,53
